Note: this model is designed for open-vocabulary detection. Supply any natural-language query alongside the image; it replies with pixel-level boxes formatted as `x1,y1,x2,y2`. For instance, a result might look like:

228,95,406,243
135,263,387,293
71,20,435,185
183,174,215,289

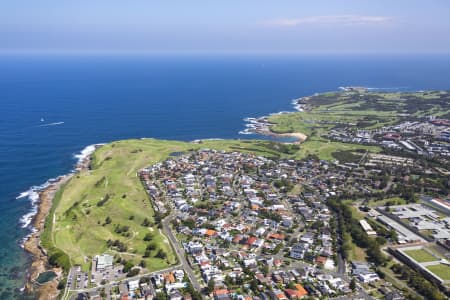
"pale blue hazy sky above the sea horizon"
0,0,450,53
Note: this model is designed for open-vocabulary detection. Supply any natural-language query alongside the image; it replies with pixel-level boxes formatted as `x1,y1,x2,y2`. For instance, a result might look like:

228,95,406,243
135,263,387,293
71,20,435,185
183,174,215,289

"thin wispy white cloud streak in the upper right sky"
264,15,391,27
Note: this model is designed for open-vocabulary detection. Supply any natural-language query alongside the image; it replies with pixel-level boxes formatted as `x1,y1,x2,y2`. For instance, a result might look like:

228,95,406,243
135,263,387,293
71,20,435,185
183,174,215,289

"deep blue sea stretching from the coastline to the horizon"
0,55,450,299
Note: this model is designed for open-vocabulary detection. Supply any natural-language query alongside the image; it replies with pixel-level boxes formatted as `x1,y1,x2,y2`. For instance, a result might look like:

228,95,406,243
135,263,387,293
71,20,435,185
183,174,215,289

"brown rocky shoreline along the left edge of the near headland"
23,145,100,300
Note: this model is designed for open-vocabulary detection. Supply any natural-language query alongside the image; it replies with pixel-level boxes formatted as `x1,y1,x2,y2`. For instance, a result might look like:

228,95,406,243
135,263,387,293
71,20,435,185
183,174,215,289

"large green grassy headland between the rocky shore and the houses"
42,139,292,270
